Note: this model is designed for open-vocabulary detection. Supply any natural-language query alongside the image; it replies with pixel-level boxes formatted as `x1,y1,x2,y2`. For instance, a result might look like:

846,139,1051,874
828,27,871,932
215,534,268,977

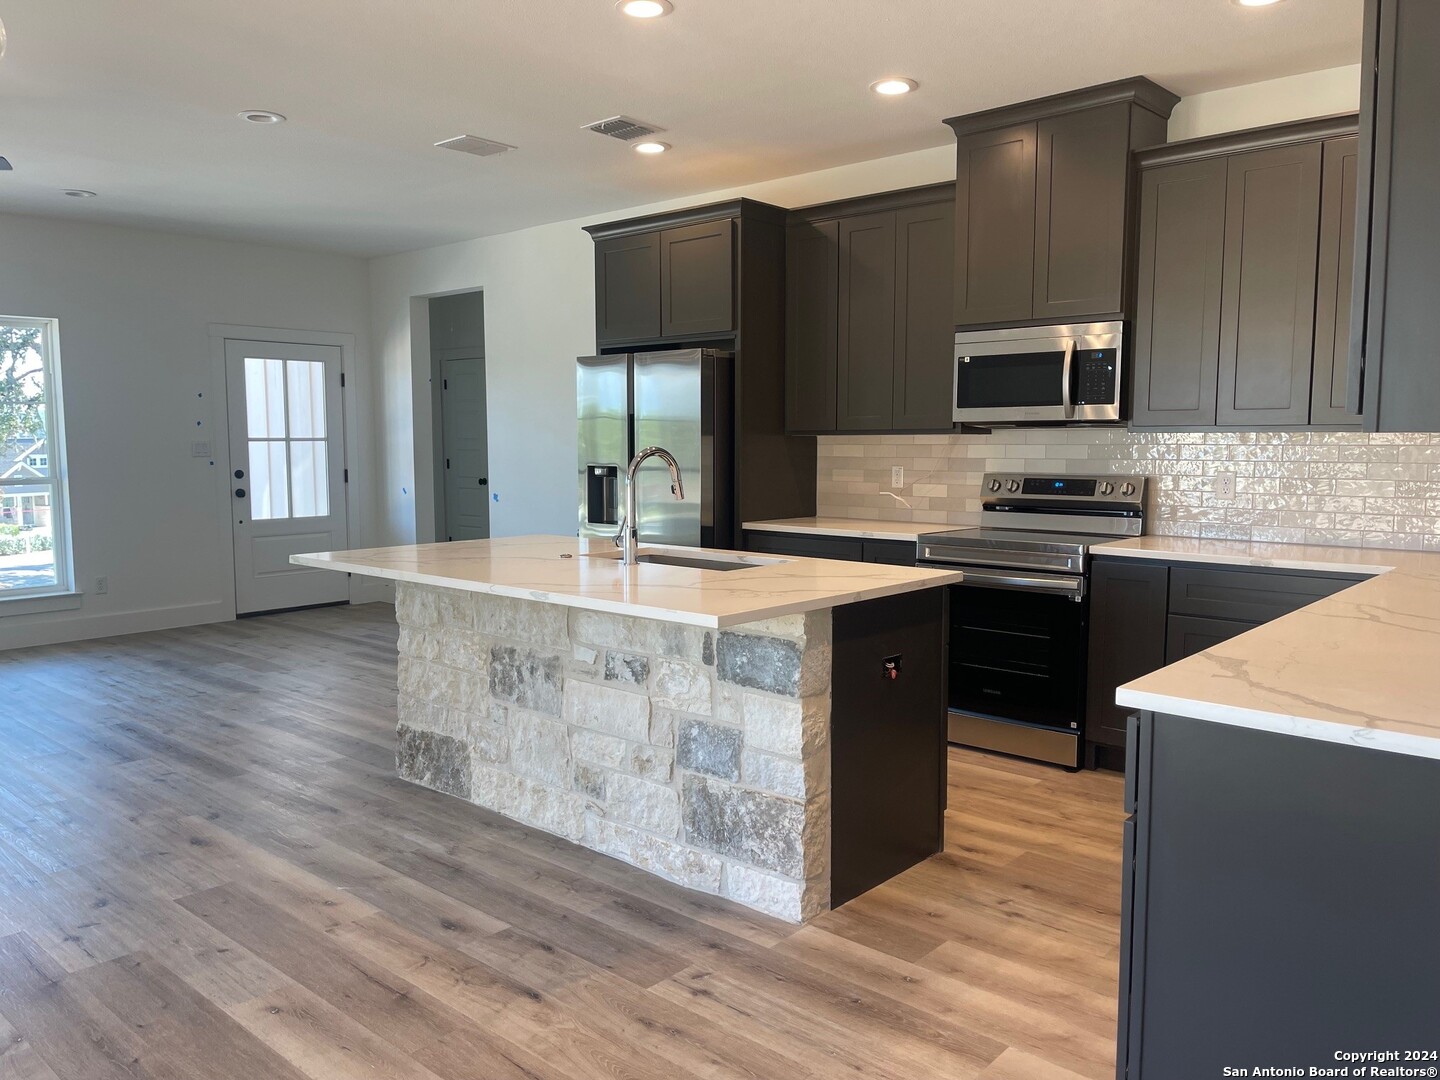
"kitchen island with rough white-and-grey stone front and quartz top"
292,536,959,922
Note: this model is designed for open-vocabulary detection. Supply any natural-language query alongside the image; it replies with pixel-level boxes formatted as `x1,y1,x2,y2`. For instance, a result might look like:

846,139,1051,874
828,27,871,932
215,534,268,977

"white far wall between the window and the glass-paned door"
0,215,373,648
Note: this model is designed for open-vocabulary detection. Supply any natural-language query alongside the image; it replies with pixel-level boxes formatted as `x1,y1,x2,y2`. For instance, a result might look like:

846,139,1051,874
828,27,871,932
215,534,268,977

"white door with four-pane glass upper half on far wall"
225,340,350,615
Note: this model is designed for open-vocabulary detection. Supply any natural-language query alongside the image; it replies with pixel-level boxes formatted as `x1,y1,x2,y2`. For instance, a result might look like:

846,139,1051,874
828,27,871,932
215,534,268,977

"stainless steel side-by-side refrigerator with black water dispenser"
576,348,734,547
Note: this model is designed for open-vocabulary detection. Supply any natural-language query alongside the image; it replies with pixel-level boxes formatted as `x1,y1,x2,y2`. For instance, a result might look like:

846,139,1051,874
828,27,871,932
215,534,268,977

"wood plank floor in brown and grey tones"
0,605,1122,1080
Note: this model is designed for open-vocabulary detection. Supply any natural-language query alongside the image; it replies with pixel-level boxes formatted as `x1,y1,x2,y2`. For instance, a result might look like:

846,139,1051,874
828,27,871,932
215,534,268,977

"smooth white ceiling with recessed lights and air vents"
0,0,1362,255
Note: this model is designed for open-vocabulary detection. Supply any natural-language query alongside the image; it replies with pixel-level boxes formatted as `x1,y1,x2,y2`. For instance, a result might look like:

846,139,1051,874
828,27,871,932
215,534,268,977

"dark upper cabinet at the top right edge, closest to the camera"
1348,0,1440,432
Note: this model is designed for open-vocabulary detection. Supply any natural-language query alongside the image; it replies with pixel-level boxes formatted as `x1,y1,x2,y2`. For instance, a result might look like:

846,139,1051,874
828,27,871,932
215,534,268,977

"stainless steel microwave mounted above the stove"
950,323,1125,423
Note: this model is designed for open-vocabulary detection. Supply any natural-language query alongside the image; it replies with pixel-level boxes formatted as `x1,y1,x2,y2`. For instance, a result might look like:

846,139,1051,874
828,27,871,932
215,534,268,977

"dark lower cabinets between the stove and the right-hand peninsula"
1086,556,1364,766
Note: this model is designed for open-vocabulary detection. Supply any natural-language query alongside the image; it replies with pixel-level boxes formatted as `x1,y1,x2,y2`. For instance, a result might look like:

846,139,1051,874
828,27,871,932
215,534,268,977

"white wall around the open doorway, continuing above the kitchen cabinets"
370,65,1359,543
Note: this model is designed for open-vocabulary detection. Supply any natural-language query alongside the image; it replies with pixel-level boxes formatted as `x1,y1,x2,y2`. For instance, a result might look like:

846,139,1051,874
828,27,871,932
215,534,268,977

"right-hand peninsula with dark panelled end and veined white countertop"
1102,537,1440,1080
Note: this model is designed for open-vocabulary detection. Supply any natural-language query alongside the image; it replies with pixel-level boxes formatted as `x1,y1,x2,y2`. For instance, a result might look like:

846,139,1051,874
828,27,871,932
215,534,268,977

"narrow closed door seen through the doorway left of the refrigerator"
441,359,490,540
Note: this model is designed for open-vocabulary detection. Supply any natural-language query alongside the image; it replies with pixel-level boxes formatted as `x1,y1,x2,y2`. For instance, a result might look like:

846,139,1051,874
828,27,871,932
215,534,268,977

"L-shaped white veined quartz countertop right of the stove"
1111,536,1440,759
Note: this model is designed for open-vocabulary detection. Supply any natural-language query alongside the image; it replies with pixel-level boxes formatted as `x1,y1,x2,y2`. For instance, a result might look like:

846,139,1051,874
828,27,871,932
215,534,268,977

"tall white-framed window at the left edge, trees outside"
0,315,73,603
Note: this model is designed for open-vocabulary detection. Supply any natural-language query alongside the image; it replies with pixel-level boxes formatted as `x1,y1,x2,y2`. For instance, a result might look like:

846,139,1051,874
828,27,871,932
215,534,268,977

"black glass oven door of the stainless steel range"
950,567,1090,734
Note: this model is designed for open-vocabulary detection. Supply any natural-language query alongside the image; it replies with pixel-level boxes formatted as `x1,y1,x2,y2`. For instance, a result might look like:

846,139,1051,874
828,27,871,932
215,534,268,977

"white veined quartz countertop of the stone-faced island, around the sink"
291,536,960,629
